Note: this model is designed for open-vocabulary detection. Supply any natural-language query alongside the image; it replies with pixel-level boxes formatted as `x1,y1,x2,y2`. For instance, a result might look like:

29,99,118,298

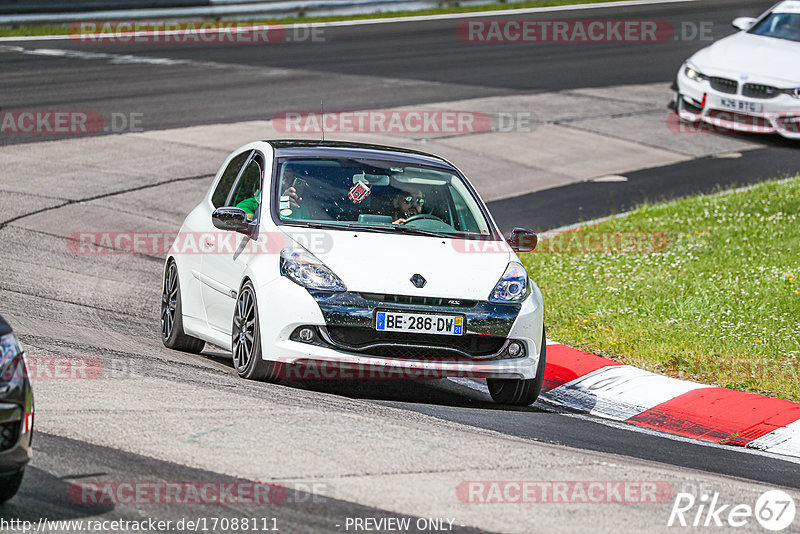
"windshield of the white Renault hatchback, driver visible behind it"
275,158,491,238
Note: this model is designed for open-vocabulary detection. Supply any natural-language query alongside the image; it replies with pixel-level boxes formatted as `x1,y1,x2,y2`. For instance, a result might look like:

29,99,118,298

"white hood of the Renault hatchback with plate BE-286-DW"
281,226,514,300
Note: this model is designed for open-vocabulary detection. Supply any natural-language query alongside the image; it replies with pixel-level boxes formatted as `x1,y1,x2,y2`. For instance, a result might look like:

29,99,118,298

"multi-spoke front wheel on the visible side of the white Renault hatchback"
231,280,279,382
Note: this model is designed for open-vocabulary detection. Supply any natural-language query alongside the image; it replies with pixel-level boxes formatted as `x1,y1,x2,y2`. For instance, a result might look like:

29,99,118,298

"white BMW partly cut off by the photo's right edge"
673,0,800,139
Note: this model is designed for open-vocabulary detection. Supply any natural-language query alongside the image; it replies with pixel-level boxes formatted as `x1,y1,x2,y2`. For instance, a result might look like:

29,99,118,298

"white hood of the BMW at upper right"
689,32,800,89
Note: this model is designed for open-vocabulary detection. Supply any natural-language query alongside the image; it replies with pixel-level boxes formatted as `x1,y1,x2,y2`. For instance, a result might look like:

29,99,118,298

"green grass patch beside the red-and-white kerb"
523,177,800,400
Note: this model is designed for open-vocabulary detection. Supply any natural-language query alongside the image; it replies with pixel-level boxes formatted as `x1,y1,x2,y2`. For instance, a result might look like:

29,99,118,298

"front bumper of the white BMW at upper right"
676,66,800,139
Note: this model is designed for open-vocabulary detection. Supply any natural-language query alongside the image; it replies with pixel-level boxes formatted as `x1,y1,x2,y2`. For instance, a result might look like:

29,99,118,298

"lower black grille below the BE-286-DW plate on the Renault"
327,326,506,360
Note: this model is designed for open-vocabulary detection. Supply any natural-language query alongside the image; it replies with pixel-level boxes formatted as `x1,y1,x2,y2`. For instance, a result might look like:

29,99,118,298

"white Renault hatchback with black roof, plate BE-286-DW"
161,140,545,405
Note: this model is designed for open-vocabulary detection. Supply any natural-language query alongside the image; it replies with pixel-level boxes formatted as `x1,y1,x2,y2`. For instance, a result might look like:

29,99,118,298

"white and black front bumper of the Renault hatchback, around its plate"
260,278,543,379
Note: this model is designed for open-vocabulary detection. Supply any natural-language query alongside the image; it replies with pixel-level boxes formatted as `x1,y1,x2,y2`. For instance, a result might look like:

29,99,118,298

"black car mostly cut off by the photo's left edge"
0,316,33,503
